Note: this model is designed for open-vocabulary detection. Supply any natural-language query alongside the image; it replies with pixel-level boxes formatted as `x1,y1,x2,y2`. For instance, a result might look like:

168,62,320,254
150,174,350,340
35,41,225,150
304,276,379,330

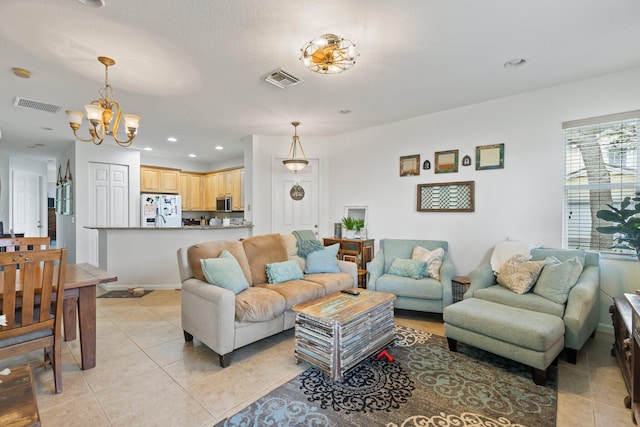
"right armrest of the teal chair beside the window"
563,265,600,350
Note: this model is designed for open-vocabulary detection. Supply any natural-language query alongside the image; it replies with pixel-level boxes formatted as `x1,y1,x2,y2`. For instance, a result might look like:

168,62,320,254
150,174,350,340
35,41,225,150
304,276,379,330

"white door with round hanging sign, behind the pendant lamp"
272,158,320,236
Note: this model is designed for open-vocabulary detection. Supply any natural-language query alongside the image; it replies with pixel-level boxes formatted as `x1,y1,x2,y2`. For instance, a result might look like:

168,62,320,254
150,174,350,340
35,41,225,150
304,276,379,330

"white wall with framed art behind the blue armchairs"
253,69,640,334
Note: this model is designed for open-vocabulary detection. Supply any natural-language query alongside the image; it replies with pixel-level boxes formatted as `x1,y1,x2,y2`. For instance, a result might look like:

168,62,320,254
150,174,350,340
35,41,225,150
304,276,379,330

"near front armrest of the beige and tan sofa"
181,279,236,356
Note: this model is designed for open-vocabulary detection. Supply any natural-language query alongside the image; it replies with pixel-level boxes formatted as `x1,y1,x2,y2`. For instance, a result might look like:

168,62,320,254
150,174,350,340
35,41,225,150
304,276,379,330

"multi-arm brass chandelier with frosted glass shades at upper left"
65,56,140,147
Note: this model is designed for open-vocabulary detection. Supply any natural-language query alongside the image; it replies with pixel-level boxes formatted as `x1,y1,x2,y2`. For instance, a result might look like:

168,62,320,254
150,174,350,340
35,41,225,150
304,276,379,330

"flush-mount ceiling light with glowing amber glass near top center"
300,34,359,74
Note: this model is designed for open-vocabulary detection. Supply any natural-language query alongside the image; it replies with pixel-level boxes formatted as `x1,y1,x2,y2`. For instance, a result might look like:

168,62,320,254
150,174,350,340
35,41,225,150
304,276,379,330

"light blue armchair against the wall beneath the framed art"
367,239,454,313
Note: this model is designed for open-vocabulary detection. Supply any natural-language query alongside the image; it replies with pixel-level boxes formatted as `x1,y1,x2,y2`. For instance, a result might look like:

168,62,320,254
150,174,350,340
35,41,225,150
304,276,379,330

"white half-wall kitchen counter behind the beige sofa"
85,225,253,290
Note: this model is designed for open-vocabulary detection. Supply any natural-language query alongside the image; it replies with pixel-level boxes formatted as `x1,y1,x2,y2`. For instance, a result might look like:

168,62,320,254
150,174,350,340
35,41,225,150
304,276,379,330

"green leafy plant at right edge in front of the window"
596,191,640,259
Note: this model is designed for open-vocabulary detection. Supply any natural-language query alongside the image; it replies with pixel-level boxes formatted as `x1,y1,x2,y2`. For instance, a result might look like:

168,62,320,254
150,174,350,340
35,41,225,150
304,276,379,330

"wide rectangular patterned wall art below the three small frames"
418,181,475,212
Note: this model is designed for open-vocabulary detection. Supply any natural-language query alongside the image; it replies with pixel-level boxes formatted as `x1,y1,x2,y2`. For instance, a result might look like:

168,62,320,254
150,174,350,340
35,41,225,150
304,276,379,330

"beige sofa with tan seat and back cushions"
178,234,357,367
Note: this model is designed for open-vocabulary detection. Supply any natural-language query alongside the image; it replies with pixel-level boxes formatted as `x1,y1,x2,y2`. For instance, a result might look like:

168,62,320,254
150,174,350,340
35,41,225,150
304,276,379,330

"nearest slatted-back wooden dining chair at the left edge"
0,249,67,393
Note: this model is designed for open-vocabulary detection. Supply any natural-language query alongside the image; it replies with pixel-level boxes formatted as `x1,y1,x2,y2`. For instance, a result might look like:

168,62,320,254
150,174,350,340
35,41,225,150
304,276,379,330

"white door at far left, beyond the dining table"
11,171,44,237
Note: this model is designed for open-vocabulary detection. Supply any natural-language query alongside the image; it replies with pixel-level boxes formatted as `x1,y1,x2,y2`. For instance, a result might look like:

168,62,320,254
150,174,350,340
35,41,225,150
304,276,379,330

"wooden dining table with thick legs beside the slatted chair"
0,263,118,369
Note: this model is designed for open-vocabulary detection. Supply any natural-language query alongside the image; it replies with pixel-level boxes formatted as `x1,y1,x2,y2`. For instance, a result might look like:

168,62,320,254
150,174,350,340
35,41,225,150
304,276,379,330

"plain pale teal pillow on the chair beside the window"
533,256,582,304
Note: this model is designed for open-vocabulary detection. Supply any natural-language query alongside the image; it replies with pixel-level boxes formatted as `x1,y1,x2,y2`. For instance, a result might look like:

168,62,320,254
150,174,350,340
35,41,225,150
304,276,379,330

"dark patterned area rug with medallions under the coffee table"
216,326,558,427
